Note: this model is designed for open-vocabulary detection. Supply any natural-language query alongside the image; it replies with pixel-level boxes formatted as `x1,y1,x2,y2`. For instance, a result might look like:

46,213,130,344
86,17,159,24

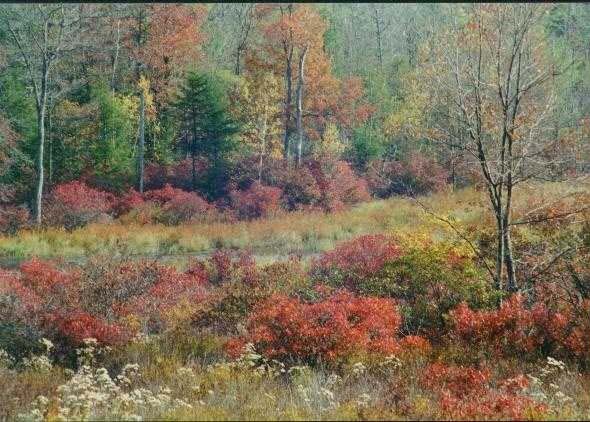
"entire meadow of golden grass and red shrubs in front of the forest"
0,183,590,420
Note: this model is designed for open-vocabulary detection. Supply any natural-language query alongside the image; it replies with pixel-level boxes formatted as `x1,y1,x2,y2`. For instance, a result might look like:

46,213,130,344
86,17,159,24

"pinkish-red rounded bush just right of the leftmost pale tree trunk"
43,181,115,229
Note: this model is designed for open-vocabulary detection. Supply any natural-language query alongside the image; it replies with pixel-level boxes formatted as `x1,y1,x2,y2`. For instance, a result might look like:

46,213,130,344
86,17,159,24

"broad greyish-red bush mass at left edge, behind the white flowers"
0,259,214,349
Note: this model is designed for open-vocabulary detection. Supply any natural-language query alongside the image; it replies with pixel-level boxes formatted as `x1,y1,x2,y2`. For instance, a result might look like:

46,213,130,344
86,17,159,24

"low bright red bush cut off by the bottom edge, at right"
420,362,547,420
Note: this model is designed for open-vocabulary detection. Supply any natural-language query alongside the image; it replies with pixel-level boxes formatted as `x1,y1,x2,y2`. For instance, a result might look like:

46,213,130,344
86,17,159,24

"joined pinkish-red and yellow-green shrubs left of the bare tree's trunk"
311,235,497,335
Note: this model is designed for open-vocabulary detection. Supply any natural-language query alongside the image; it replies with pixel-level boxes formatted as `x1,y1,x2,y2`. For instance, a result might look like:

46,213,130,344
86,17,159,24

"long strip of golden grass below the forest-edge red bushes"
0,183,588,259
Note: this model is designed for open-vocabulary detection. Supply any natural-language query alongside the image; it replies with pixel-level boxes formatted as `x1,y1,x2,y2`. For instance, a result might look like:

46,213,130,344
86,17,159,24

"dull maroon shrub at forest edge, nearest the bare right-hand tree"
367,153,448,198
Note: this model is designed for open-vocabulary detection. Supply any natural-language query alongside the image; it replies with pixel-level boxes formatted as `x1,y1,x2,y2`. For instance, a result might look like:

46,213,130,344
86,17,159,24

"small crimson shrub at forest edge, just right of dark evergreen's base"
230,182,283,220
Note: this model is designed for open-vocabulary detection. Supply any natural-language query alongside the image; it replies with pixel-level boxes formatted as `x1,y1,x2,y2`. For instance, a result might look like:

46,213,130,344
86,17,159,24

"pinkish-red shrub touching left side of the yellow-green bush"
312,234,401,290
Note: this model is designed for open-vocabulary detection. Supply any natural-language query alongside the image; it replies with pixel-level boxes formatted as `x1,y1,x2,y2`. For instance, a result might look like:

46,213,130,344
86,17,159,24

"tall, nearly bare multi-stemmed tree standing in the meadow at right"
424,4,560,291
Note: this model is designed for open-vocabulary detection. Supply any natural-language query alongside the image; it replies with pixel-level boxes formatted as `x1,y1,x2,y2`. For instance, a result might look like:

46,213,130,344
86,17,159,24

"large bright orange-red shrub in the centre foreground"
229,291,401,361
